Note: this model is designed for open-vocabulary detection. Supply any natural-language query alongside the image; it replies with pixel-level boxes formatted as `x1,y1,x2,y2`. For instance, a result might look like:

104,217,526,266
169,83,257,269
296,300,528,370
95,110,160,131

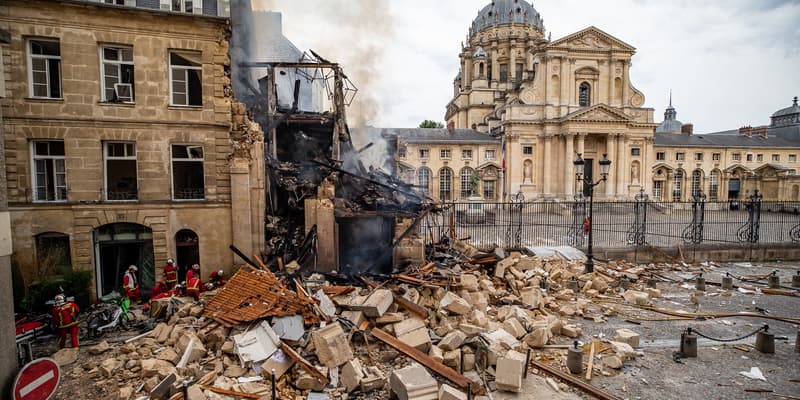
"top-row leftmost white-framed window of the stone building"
28,39,61,99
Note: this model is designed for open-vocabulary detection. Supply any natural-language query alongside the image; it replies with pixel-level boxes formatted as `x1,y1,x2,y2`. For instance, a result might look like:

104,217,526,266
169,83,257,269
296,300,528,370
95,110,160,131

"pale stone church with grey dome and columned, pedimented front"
444,0,656,200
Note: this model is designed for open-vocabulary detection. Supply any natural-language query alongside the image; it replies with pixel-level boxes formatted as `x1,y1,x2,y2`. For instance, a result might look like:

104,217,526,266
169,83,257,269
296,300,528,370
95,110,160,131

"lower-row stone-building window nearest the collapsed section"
172,144,205,200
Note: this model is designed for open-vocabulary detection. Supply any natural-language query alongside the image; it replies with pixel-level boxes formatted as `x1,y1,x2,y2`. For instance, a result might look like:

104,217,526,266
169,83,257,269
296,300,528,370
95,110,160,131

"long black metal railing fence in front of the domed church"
419,195,800,250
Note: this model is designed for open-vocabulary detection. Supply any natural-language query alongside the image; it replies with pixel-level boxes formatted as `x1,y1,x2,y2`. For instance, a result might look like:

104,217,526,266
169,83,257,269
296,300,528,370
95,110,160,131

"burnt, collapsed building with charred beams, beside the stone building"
231,3,429,275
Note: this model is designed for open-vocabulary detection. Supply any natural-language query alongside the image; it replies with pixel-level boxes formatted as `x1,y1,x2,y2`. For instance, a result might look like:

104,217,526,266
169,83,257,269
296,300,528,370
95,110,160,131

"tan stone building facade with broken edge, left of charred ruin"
0,1,263,296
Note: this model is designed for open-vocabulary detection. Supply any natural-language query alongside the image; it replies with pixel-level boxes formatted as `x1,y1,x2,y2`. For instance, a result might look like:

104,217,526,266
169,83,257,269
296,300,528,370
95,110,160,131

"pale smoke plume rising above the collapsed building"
252,0,400,127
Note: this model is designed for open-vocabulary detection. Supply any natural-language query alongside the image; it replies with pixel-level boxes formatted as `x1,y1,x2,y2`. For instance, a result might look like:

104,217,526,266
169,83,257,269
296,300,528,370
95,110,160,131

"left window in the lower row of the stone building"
33,140,67,201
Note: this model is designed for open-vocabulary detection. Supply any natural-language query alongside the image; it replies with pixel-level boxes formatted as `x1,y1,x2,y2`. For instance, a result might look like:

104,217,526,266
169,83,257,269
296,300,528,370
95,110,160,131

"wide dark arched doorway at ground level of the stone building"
93,223,155,298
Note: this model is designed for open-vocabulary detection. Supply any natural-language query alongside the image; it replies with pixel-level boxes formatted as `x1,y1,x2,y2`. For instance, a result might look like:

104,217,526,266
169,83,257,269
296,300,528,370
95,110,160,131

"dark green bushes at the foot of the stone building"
19,270,92,312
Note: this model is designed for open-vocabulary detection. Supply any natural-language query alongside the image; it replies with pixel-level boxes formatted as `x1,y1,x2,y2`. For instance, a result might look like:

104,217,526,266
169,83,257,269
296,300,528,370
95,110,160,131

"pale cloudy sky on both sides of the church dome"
253,0,800,133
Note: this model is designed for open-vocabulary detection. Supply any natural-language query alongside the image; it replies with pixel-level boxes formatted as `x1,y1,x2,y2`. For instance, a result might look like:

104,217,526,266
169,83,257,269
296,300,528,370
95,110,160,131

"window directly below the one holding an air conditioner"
105,142,139,200
